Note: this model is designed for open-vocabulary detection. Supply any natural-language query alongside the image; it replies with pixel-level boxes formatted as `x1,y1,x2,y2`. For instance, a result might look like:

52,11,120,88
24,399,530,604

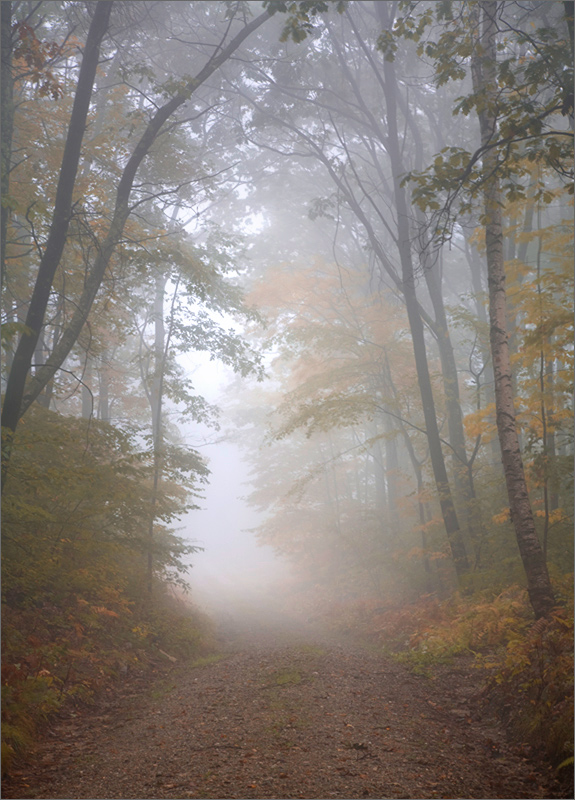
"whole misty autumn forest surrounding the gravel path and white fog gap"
0,0,574,797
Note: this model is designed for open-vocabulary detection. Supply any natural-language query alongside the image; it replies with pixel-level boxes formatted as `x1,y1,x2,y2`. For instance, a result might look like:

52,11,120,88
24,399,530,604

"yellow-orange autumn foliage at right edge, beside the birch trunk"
465,189,573,569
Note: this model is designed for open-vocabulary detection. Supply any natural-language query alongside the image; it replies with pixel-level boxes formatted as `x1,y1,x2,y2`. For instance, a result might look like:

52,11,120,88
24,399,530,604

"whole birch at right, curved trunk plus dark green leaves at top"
380,2,573,617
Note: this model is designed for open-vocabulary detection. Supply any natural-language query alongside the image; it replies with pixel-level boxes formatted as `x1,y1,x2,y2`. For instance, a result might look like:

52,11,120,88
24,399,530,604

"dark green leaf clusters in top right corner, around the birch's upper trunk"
388,0,573,242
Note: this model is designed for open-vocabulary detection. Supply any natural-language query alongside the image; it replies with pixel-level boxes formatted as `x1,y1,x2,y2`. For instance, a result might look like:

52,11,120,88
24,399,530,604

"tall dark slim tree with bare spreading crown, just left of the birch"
230,3,469,575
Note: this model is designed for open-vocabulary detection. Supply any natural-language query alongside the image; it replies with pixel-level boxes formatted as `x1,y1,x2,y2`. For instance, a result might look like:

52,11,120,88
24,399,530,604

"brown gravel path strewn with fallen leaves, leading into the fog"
3,608,566,798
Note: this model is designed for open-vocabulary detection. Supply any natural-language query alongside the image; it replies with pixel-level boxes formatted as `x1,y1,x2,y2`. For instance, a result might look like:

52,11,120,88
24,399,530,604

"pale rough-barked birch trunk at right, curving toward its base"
472,0,555,618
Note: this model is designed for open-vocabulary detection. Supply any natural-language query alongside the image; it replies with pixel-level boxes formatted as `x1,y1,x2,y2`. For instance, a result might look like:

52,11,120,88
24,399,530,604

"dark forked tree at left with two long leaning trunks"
2,2,270,477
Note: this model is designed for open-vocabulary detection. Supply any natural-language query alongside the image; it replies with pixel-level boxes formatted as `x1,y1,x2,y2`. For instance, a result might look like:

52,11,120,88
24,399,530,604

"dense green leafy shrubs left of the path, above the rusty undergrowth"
3,407,208,604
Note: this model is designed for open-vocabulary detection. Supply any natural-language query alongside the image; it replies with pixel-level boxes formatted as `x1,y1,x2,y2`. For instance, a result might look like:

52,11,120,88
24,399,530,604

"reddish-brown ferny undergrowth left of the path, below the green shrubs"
2,596,213,775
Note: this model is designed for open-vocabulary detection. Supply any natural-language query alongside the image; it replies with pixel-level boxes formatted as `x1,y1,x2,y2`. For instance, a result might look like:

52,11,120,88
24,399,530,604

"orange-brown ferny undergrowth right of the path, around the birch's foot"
342,575,574,772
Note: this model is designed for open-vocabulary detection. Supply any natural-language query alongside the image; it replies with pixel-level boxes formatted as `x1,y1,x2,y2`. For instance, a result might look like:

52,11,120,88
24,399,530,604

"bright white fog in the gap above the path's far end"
180,355,292,621
